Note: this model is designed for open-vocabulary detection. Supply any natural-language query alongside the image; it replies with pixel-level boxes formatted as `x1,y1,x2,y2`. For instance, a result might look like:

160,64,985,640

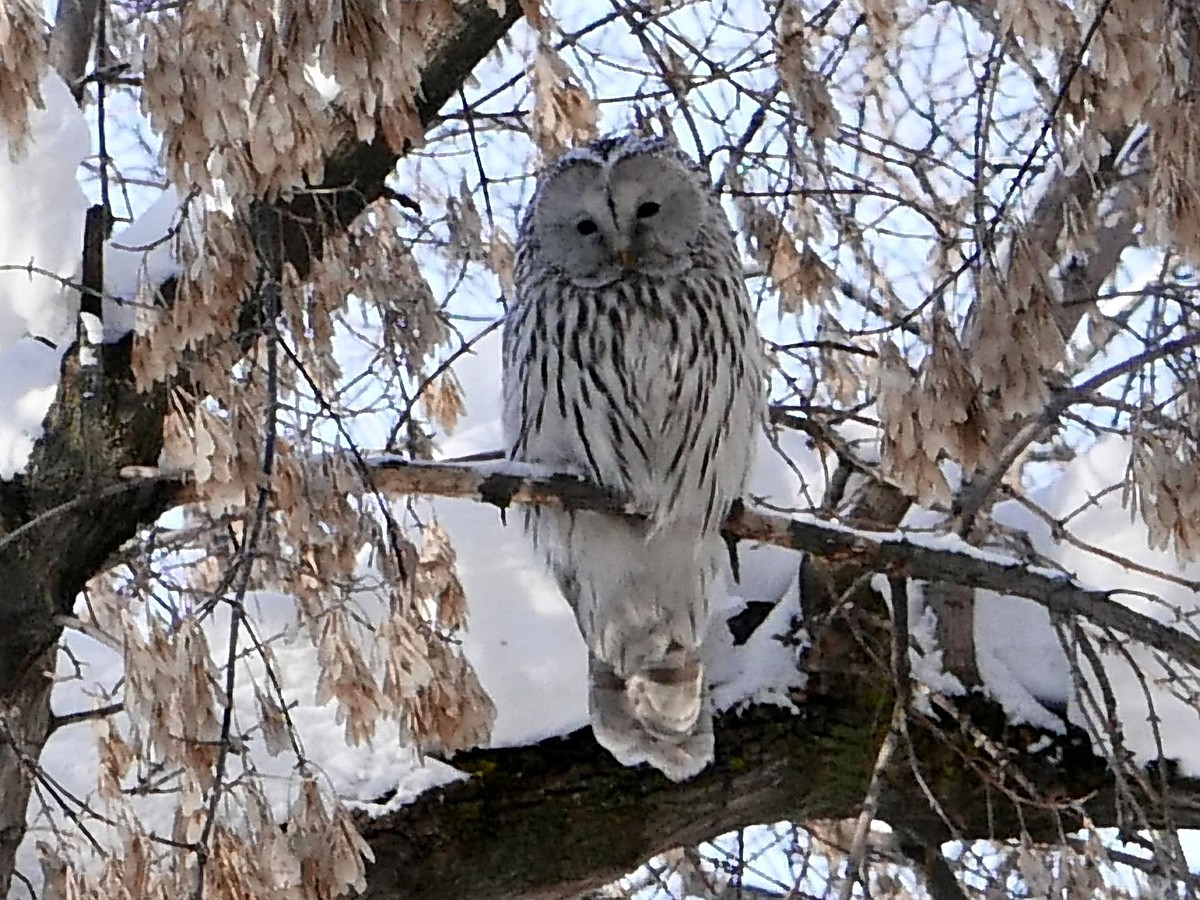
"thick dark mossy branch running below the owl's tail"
359,686,1200,900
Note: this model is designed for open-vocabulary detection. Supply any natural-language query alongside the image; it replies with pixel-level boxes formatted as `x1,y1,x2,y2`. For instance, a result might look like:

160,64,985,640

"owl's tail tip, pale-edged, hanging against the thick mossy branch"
589,656,713,781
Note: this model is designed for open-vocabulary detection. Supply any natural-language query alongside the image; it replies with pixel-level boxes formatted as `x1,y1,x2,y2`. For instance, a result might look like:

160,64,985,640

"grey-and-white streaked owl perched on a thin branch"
503,136,767,781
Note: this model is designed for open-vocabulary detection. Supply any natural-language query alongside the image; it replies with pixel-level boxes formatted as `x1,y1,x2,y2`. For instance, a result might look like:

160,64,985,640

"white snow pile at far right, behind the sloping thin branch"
974,436,1200,778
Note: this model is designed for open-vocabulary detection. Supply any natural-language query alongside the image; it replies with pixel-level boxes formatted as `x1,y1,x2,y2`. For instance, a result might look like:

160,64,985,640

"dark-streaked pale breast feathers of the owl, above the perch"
505,256,761,530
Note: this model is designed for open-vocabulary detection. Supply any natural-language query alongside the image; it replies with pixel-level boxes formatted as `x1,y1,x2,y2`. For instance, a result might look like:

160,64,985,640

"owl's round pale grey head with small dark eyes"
521,136,728,288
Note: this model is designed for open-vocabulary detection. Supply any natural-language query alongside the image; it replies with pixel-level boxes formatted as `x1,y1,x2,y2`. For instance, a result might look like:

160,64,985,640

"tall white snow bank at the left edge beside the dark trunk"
0,72,91,479
